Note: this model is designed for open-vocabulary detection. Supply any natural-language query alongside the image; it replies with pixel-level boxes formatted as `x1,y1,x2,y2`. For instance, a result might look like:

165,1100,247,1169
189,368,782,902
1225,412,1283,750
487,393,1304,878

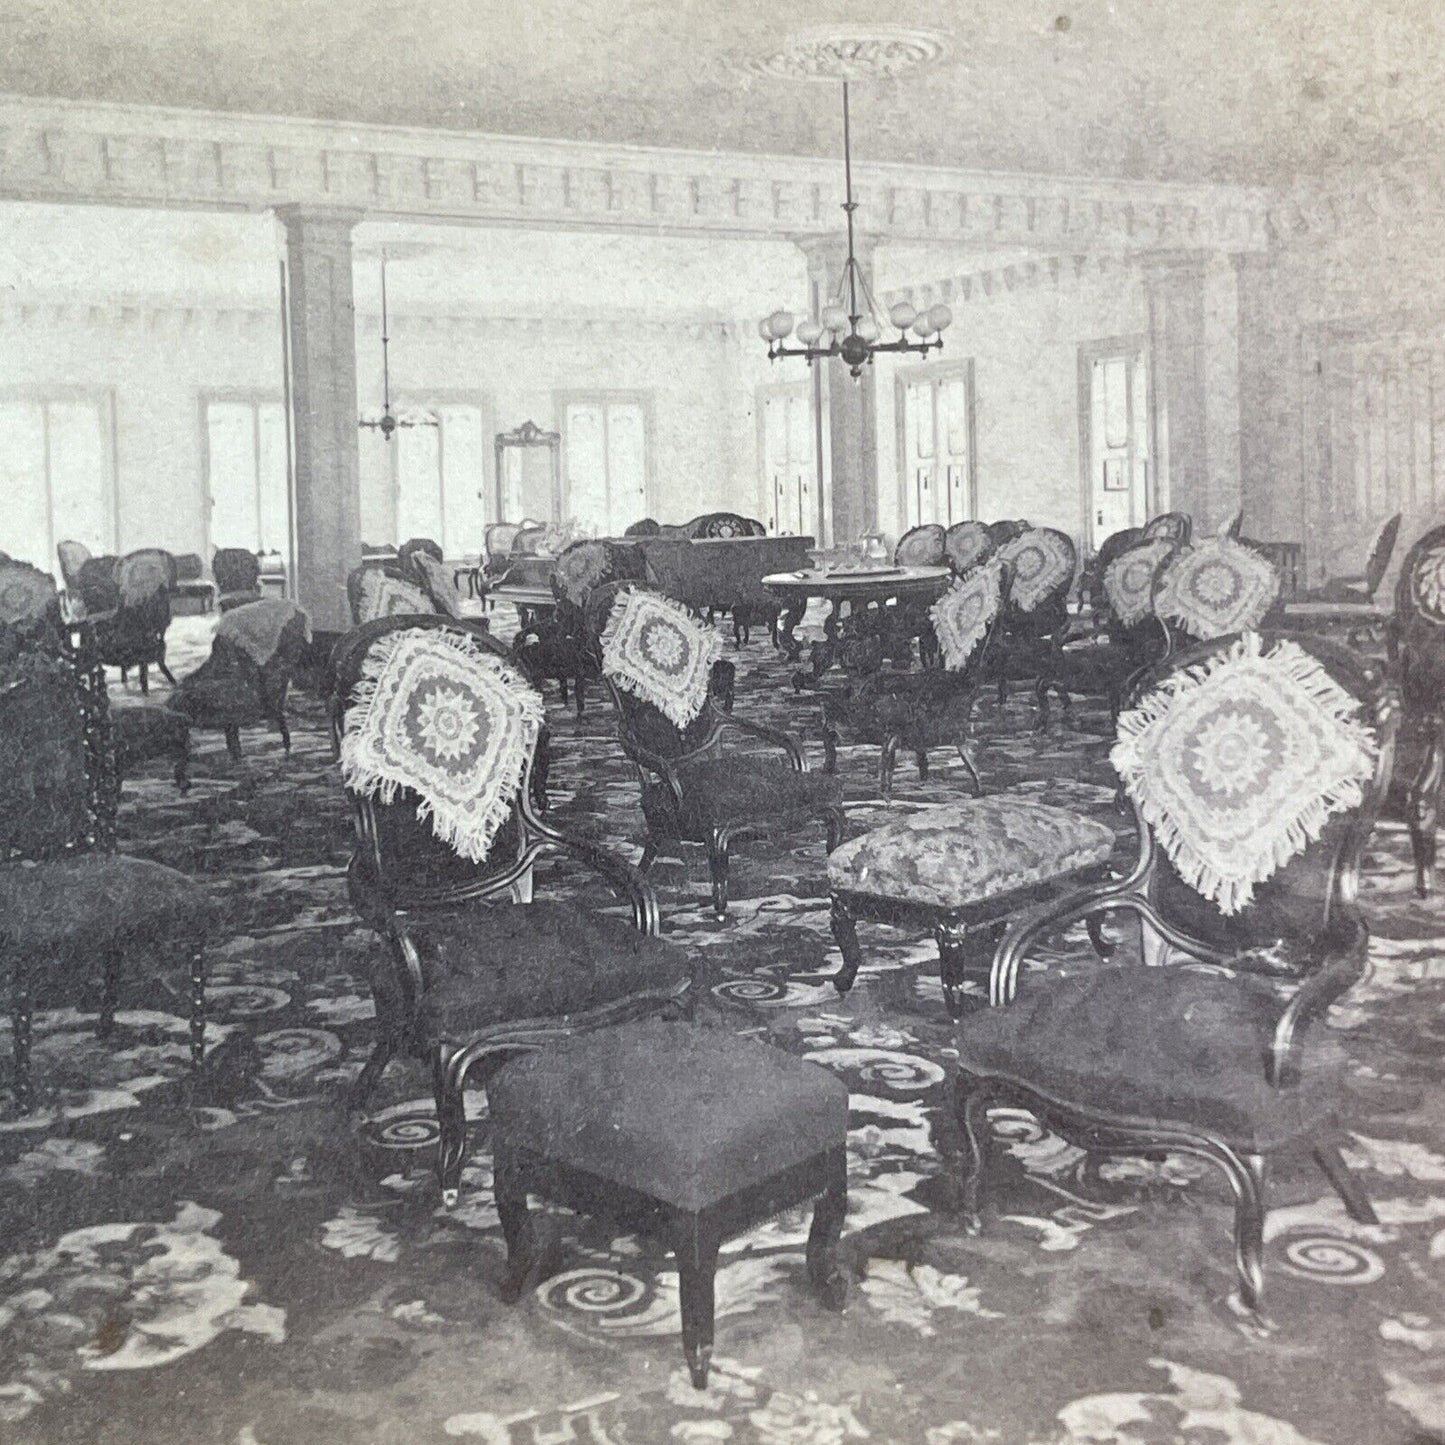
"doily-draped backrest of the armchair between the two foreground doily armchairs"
585,582,721,759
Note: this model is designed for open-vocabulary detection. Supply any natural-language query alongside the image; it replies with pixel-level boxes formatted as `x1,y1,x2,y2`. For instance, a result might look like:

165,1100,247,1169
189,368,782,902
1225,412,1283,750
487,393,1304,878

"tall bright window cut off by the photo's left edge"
0,392,116,572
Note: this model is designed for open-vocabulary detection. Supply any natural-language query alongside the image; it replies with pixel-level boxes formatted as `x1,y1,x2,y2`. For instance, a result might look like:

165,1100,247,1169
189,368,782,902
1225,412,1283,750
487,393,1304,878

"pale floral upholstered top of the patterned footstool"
828,795,1114,907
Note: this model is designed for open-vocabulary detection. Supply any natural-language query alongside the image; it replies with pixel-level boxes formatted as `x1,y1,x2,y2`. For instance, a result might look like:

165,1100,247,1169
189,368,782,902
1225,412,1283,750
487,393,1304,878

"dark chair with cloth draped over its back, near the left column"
171,597,311,760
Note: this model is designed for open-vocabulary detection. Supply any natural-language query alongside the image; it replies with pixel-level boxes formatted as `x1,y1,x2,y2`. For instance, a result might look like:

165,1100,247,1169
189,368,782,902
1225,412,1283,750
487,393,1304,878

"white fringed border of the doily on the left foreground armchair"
341,630,545,863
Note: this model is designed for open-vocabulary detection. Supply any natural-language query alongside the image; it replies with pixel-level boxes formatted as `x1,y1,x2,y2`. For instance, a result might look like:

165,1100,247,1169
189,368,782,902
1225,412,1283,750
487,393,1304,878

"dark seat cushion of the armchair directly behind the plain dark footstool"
407,899,689,1046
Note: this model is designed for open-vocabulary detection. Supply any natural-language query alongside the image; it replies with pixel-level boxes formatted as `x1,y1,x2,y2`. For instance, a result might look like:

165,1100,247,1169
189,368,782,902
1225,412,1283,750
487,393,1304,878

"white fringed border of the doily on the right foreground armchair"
1108,631,1379,915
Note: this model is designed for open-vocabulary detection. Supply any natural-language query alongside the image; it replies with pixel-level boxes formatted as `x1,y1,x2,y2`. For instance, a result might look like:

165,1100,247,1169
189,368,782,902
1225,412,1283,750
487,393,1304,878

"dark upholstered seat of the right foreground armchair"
958,965,1340,1153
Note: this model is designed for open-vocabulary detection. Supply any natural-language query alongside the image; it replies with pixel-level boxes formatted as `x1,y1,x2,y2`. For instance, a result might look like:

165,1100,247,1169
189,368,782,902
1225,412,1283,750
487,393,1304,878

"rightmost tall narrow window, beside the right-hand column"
1079,338,1153,551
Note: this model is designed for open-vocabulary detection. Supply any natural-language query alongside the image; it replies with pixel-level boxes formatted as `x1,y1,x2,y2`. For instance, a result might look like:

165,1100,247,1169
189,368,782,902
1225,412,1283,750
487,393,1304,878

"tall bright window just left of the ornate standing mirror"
390,397,487,558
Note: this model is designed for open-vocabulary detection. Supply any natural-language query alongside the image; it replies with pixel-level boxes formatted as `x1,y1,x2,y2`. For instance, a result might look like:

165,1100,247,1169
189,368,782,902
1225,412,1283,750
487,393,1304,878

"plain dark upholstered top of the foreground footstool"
487,1020,848,1211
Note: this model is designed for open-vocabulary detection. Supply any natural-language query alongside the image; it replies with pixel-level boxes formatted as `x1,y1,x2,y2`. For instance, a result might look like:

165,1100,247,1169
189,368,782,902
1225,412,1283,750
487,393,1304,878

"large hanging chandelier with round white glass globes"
757,81,954,377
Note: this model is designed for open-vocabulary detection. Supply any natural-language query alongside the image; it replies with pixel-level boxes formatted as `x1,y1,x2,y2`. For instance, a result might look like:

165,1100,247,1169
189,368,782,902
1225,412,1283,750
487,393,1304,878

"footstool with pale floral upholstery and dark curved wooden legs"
828,793,1114,1017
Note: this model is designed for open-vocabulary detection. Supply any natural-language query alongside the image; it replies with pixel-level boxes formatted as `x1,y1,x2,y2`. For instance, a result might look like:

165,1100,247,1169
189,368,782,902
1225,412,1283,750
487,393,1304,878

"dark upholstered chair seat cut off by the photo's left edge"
0,853,214,949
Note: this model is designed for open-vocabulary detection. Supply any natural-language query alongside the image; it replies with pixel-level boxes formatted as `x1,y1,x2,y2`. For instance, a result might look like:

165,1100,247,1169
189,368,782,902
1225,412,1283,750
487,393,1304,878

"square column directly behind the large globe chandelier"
779,234,879,543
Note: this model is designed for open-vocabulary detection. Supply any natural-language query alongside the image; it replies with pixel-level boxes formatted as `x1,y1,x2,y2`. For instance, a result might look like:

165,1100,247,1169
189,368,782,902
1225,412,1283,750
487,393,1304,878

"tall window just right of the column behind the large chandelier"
897,361,977,527
